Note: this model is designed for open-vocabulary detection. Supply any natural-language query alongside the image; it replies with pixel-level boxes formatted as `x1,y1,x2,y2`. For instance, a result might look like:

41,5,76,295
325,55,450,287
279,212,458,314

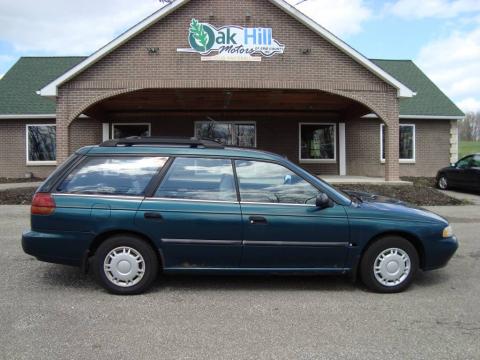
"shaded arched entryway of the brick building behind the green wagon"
61,89,398,180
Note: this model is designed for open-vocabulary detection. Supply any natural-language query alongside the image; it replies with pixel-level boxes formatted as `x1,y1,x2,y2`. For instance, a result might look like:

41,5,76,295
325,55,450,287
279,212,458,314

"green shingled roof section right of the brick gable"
372,59,464,116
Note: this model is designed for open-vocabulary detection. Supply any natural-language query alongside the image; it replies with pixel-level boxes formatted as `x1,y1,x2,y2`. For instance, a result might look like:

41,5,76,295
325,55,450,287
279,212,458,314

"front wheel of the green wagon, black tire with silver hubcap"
360,236,419,293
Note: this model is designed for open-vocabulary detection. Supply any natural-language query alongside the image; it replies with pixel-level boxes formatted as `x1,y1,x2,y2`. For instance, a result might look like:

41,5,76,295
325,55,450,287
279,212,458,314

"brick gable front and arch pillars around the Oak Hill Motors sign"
57,0,398,180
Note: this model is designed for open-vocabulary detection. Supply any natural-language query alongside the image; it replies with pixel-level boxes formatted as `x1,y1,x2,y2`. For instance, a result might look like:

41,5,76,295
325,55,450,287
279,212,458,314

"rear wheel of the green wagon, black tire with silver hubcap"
93,234,159,295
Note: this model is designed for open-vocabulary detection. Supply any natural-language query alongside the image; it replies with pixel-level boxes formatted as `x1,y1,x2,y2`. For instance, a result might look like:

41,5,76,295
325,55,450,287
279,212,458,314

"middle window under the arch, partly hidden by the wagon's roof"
195,121,257,148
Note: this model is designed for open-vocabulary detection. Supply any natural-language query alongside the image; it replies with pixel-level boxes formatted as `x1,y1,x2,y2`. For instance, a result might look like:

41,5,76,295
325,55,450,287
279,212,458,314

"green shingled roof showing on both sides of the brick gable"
0,57,464,116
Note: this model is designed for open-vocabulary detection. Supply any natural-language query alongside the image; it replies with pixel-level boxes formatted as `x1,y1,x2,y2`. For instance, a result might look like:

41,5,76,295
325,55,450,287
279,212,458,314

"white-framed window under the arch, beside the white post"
300,123,337,162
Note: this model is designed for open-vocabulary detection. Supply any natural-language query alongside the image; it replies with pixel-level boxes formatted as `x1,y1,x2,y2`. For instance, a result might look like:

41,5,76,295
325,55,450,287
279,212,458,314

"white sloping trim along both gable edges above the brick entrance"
37,0,416,98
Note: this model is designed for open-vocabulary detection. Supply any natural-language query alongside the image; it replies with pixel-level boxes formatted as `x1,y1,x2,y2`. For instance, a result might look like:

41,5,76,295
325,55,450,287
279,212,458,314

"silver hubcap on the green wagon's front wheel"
373,248,411,287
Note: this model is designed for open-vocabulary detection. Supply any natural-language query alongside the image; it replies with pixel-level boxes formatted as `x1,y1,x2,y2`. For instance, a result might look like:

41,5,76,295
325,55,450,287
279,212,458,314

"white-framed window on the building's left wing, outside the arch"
27,124,57,165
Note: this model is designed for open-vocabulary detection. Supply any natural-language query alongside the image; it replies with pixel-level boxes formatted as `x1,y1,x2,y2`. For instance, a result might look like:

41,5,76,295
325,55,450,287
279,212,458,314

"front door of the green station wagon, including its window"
235,160,349,269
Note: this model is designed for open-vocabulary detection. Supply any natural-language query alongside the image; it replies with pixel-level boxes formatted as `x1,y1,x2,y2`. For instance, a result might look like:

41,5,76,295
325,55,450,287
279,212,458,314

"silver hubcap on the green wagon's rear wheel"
103,246,145,287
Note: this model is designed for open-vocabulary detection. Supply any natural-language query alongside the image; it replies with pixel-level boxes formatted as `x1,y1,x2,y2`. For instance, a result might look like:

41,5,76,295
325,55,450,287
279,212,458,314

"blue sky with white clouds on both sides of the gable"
0,0,480,111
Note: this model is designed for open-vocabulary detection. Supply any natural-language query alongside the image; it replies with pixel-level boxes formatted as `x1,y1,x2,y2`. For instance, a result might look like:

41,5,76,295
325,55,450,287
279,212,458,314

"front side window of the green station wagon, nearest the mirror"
235,160,319,205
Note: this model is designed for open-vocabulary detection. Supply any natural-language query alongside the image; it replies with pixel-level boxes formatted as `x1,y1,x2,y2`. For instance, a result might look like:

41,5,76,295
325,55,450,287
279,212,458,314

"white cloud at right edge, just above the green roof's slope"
417,26,480,110
